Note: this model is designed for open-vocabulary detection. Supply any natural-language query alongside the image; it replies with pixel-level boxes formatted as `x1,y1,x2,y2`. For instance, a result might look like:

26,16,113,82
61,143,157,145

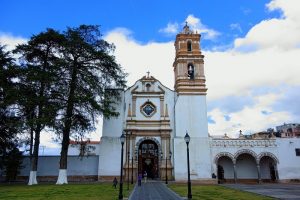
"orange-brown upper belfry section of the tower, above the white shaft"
173,24,207,95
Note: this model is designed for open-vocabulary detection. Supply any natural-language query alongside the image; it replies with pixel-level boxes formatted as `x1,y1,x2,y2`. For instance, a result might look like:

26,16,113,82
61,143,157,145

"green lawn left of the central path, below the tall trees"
0,183,134,200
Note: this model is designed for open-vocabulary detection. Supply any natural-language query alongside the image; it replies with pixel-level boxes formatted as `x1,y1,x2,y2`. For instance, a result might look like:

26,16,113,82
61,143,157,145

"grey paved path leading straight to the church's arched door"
129,181,182,200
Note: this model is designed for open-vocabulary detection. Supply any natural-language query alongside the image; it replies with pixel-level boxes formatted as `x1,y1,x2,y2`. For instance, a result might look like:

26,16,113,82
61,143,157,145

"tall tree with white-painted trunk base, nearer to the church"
56,25,126,184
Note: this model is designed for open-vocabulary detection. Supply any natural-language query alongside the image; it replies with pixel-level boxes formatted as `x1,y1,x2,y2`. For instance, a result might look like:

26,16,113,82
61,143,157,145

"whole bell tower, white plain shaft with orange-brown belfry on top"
173,24,214,182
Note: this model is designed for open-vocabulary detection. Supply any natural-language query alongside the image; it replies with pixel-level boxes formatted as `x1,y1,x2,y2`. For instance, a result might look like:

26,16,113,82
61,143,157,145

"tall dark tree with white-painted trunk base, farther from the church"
14,29,63,185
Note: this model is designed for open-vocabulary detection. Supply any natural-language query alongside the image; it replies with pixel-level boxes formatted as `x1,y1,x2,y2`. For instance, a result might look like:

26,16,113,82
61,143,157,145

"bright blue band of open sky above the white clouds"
0,0,279,48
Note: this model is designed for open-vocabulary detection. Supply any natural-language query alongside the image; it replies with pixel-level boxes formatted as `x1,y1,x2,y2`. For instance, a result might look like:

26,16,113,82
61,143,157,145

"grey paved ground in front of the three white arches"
223,183,300,200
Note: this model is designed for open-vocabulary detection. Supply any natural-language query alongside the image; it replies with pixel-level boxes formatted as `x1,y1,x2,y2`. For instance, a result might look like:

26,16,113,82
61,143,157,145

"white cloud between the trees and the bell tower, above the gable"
104,29,175,88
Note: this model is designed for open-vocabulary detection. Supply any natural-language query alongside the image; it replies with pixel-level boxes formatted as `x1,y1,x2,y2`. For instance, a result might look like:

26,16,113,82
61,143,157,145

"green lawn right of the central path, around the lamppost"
169,184,273,200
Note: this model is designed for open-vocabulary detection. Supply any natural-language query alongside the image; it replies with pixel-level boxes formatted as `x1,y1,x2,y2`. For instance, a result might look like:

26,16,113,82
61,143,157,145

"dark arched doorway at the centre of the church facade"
138,140,159,179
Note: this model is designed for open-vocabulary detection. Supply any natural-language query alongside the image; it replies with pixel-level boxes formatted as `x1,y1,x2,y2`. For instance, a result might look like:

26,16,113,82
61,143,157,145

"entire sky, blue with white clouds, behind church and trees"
0,0,300,155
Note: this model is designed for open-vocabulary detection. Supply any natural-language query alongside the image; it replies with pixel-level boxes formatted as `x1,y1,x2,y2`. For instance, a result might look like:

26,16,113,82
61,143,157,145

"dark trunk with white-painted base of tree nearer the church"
56,65,77,185
